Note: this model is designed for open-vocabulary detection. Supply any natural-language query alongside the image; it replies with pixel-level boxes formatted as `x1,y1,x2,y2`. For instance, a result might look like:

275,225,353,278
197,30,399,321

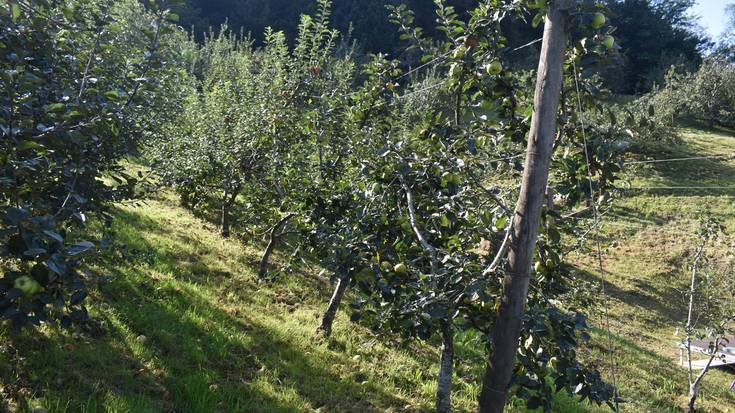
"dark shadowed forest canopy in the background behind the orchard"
179,0,709,94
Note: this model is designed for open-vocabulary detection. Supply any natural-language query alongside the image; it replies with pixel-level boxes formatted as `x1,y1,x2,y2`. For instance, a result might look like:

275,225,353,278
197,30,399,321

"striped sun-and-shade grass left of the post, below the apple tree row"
0,191,604,413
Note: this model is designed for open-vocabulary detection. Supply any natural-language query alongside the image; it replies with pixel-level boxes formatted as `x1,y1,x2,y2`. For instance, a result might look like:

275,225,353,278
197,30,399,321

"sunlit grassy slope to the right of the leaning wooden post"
575,129,735,412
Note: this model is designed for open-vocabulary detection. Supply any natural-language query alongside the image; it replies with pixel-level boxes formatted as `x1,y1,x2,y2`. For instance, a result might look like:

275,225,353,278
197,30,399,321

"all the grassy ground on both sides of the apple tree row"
0,125,735,412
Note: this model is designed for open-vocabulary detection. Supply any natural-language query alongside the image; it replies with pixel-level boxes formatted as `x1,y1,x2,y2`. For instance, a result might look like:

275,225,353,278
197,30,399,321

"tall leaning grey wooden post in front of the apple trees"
479,1,569,413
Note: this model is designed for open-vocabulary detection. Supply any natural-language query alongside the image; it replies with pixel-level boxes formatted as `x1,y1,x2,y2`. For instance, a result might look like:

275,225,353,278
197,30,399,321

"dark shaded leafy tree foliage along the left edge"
0,1,184,326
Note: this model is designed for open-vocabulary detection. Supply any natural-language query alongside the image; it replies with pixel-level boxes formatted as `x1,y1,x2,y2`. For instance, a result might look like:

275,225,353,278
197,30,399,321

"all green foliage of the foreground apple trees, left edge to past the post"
0,0,677,410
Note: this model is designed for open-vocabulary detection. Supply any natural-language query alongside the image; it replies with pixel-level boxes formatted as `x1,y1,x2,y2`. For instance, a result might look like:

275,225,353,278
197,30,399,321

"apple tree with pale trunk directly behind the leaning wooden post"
338,2,617,411
